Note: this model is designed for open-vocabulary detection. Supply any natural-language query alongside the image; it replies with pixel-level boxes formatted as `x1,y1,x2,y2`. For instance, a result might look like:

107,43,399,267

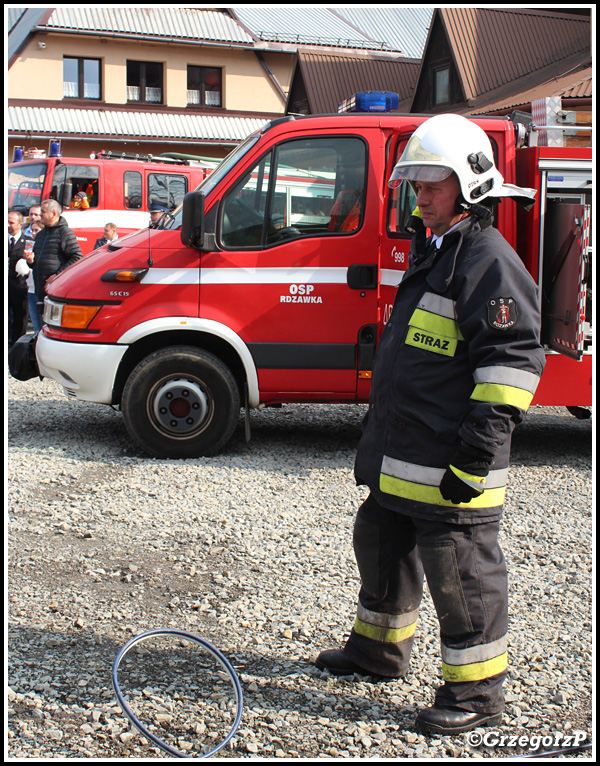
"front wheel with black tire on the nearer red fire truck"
121,346,240,458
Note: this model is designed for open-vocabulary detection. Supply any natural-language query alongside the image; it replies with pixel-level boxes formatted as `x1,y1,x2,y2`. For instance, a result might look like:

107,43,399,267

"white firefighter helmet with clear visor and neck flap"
388,114,535,205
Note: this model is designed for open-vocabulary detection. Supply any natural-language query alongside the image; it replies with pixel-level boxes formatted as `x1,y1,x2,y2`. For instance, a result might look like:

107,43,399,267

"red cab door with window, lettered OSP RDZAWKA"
200,136,379,401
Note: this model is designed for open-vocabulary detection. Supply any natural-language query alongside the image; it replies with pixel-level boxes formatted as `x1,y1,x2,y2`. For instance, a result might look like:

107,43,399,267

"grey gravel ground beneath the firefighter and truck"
6,368,592,760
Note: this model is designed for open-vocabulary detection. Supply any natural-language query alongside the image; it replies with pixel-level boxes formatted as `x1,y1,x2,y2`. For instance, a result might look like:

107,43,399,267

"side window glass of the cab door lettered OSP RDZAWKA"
220,138,367,249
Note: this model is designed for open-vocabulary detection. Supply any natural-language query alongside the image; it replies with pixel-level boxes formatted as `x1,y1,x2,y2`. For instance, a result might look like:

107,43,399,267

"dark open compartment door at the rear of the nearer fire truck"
542,176,592,360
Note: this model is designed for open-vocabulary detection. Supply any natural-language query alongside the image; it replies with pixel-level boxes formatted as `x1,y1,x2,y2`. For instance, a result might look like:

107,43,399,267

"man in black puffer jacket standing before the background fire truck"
33,199,83,302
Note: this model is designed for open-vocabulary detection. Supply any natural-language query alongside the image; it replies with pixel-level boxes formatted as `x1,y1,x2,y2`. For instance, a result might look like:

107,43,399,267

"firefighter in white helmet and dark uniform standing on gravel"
315,114,544,735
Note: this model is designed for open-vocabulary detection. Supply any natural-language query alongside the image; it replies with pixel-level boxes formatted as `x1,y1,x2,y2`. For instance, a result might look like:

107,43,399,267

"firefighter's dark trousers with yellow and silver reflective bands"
345,496,508,713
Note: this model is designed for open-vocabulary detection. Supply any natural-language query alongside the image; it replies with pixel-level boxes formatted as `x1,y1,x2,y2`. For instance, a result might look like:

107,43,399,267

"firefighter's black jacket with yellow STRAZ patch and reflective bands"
355,217,545,524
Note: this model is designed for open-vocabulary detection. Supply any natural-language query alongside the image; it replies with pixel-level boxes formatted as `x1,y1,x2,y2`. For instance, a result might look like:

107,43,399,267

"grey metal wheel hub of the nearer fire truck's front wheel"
154,380,208,436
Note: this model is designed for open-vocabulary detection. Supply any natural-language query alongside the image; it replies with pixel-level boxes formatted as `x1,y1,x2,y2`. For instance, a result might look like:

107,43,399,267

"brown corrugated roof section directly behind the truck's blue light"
288,50,421,114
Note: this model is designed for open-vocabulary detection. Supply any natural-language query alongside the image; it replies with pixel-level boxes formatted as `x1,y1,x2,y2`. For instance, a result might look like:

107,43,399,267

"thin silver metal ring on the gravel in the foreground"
112,628,243,758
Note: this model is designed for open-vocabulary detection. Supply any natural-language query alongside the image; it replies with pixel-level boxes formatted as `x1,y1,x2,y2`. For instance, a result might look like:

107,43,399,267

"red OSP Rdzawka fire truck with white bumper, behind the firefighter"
37,96,592,458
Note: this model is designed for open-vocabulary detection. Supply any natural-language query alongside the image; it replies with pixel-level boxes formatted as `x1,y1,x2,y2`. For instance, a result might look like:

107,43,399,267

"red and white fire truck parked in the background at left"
8,147,217,255
